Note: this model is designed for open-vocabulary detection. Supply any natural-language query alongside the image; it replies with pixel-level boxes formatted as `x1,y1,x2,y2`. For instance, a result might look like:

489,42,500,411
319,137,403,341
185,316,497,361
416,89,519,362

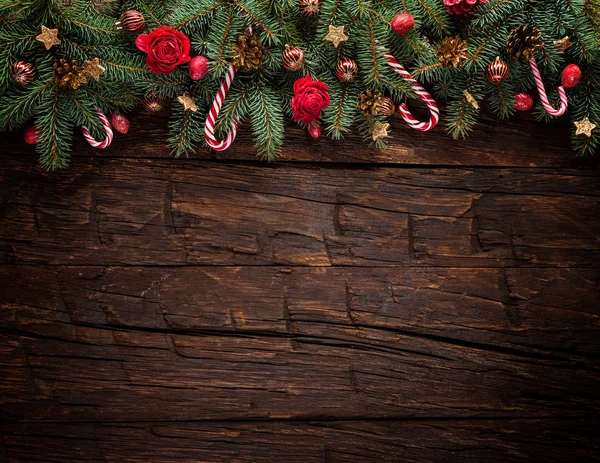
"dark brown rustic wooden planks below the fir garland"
0,114,600,463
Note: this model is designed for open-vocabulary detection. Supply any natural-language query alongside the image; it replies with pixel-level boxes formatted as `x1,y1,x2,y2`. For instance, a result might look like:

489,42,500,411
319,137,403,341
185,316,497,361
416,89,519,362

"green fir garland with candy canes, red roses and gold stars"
0,0,600,169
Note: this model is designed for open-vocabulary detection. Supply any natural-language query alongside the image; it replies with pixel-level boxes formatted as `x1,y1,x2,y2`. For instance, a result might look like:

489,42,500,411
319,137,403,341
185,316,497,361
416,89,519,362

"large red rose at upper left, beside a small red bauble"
135,26,191,74
